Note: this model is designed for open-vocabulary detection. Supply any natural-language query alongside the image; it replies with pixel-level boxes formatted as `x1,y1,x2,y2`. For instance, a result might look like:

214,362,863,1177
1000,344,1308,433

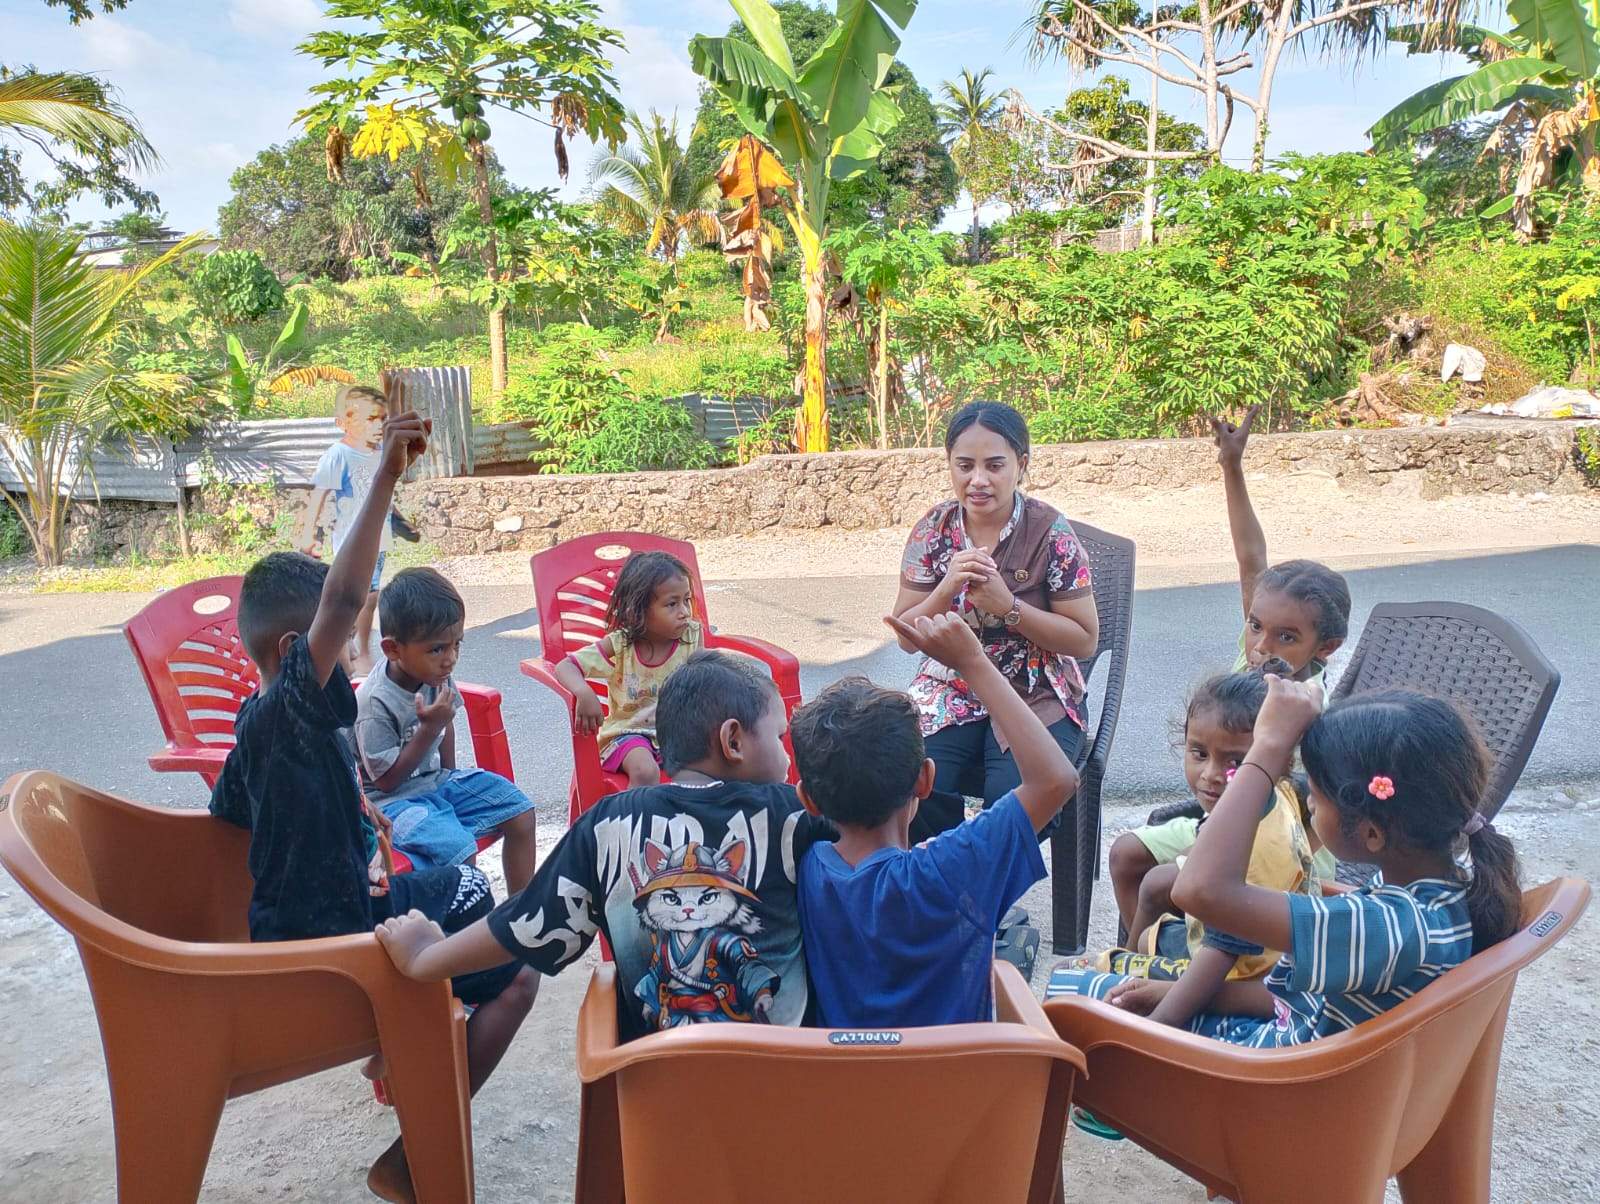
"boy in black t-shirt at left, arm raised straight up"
211,389,538,1201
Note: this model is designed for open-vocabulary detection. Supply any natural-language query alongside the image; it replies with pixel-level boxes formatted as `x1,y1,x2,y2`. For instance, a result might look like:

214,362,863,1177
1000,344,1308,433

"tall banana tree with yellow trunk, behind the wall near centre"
690,0,917,452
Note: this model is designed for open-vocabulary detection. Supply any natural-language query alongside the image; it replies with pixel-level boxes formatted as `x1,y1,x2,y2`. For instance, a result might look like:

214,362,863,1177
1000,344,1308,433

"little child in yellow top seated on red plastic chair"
555,552,701,788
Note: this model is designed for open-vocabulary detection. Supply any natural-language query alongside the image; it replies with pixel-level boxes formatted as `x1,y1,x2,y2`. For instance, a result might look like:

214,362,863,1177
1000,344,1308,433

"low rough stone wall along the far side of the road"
403,419,1584,556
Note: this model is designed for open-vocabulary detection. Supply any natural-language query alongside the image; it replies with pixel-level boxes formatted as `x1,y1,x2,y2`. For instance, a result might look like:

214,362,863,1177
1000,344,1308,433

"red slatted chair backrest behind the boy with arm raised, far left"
123,576,261,749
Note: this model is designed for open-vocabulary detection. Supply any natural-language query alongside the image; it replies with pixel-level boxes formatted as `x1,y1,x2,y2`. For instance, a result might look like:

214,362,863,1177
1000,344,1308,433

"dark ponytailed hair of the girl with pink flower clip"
1301,690,1522,953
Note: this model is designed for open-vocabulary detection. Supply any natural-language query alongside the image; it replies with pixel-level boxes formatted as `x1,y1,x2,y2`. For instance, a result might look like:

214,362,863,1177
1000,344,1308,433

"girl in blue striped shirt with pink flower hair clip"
1056,677,1522,1047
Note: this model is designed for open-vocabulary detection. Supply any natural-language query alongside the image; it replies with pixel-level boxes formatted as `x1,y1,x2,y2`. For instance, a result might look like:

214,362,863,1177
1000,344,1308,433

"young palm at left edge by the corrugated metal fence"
0,221,202,565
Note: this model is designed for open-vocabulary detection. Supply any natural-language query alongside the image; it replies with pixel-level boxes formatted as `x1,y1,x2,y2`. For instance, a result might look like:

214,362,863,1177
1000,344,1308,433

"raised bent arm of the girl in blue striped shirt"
1173,676,1322,949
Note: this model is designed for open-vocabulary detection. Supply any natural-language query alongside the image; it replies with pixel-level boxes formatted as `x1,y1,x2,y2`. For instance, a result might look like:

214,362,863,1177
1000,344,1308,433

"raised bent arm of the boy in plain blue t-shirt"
885,615,1078,831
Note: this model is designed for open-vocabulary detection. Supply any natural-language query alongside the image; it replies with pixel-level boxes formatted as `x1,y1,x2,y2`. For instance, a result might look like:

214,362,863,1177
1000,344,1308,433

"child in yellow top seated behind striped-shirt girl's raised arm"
1048,660,1318,1025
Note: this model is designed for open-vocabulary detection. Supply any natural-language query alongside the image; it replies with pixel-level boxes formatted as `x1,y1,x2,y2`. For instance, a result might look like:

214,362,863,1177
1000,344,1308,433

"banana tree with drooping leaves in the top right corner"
1368,0,1600,237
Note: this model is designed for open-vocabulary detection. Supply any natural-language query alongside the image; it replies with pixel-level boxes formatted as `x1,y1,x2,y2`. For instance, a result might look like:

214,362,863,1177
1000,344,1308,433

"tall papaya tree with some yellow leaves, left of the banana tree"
298,0,624,394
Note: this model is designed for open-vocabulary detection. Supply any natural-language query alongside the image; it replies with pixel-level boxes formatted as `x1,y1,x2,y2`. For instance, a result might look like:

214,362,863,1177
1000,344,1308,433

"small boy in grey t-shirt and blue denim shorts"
354,568,538,892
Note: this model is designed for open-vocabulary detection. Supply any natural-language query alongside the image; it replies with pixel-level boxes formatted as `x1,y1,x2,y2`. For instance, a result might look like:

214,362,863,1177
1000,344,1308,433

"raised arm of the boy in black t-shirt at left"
306,383,434,685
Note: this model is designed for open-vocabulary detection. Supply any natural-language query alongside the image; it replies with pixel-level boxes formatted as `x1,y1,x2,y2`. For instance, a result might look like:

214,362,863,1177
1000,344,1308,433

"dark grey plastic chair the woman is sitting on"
1050,522,1134,954
